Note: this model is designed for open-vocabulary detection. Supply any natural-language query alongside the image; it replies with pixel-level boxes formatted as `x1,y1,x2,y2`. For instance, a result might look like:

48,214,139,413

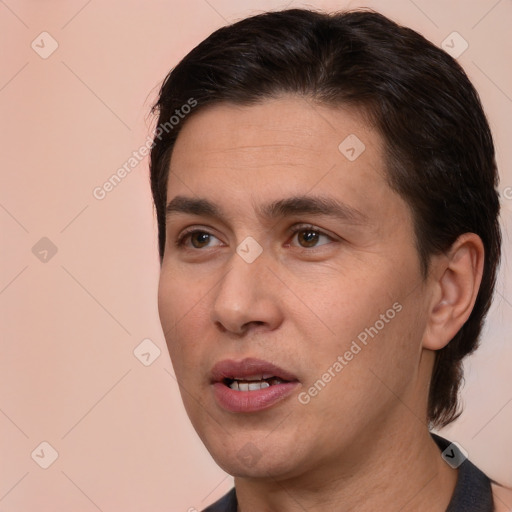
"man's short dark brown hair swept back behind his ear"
150,9,501,426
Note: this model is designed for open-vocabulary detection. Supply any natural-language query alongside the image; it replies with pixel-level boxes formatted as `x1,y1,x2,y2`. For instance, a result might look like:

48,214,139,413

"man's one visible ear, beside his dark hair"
423,233,484,350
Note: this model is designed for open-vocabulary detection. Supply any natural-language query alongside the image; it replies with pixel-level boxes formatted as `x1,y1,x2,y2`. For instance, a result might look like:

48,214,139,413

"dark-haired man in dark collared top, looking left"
151,10,505,512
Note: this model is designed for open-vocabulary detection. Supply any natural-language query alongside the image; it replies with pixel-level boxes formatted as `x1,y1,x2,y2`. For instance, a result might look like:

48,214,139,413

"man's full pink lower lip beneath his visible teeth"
213,382,299,412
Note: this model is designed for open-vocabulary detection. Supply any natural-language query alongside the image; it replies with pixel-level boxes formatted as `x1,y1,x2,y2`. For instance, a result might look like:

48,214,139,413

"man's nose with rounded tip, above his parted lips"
211,248,283,335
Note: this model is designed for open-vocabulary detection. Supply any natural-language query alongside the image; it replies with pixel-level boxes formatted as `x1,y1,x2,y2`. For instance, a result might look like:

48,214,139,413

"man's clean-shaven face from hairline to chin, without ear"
159,96,429,479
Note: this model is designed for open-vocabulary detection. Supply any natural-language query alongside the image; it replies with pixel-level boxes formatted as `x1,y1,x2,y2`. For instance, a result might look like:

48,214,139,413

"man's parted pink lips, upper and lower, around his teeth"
211,358,300,412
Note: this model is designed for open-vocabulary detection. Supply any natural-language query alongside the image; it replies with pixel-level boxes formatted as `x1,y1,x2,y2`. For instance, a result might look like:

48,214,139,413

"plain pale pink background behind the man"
0,0,512,512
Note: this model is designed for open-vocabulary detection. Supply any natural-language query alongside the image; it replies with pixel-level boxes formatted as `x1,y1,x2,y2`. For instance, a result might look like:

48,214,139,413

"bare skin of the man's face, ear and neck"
159,96,492,512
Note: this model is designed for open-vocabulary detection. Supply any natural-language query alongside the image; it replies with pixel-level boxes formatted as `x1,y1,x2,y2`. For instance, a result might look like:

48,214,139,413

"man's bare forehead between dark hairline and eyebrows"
167,96,406,228
